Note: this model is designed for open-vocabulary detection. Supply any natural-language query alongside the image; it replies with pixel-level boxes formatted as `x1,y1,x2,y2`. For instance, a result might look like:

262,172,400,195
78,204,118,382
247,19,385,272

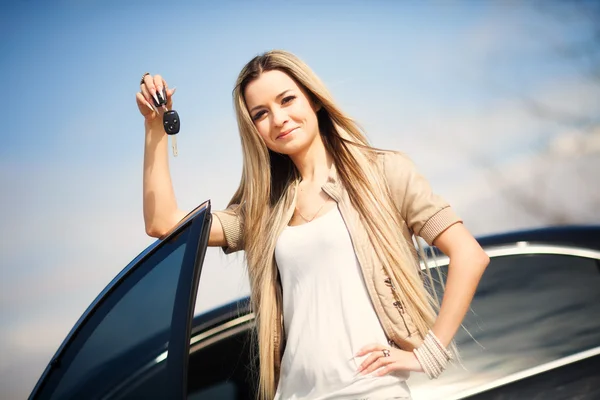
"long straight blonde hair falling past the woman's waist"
230,50,439,399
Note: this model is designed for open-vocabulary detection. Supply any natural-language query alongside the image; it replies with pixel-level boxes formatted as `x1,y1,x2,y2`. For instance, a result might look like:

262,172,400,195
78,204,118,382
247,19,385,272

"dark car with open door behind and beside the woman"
29,201,600,400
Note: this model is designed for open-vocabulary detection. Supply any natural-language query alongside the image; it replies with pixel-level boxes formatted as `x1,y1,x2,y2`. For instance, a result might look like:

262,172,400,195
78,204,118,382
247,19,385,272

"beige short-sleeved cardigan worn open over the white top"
213,152,462,376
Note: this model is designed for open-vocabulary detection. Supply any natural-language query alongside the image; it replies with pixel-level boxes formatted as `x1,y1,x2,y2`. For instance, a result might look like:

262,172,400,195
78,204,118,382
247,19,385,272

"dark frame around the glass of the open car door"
29,200,212,400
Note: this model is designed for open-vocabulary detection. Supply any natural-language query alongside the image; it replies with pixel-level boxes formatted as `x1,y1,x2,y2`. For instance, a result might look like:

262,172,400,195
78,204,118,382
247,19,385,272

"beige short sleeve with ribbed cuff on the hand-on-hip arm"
384,153,463,245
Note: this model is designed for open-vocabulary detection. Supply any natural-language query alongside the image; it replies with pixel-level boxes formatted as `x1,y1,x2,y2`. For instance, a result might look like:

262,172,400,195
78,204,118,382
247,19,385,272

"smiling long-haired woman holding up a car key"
137,51,489,399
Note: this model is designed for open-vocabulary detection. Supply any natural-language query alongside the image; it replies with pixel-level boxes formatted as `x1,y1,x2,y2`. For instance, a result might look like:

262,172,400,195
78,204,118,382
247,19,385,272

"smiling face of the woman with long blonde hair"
244,70,319,155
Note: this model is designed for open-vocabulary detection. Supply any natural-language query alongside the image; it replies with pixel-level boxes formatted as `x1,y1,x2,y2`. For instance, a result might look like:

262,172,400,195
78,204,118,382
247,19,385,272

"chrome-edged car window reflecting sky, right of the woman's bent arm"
409,254,600,399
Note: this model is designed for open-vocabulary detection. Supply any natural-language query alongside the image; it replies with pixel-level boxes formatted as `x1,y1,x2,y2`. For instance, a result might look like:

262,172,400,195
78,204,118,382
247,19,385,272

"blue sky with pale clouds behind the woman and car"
0,0,600,397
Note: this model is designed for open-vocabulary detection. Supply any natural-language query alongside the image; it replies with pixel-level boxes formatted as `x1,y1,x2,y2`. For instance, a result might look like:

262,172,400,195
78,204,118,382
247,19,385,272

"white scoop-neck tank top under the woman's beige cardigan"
275,207,410,400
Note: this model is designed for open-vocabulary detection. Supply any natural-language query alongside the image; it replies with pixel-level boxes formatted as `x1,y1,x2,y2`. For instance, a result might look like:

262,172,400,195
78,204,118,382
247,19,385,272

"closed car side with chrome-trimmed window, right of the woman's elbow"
409,242,600,400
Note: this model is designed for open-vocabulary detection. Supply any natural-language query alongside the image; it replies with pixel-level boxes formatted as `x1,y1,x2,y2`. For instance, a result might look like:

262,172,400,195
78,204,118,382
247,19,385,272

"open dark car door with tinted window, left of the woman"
29,201,211,400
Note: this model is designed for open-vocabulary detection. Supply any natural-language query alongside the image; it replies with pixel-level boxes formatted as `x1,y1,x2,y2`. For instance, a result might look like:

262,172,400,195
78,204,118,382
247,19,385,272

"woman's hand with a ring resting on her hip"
355,344,423,376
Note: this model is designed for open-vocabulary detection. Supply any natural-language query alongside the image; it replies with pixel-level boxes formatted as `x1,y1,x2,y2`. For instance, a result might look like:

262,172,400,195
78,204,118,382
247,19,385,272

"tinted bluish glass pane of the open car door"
39,227,190,399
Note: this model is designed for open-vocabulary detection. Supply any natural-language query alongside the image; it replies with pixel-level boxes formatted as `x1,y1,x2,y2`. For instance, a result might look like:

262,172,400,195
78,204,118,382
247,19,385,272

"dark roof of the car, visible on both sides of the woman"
192,225,600,334
